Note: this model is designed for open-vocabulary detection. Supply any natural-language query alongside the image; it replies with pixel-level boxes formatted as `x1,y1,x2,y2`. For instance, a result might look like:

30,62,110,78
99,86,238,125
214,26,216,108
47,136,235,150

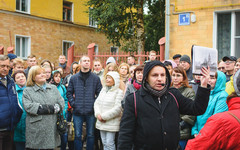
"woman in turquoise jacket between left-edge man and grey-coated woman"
12,71,26,150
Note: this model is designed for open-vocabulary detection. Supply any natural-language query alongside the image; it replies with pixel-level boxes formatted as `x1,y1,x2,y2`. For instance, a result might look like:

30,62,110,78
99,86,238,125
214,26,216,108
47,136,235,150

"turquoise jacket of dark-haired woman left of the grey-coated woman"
14,85,26,142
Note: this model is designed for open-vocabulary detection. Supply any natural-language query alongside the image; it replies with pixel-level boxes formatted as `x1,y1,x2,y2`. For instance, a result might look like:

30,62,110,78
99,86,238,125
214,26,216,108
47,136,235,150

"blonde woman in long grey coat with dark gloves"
23,66,64,149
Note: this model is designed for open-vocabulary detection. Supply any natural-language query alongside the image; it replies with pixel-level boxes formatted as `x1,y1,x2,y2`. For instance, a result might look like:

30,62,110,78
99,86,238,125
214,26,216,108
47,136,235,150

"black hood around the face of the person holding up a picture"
142,60,171,90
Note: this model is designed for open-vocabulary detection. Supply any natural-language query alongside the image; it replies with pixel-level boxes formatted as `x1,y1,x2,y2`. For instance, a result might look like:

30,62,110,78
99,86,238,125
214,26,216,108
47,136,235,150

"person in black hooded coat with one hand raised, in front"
118,61,210,150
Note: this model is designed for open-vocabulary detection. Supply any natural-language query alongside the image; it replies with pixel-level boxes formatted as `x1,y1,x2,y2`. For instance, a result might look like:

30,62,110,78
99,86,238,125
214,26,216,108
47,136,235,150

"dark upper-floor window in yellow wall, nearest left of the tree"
63,1,73,22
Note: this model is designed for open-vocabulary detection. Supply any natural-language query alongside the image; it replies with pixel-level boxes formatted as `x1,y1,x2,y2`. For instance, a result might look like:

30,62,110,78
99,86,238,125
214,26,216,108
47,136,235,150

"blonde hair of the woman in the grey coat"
27,66,44,86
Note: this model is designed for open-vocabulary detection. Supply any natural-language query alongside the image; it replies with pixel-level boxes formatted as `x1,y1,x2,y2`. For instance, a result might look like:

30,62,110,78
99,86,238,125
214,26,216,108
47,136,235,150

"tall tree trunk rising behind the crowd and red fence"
137,0,145,64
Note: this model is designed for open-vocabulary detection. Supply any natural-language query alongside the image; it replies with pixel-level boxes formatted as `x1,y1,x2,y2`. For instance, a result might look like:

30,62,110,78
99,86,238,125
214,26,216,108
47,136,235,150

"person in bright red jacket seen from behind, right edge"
185,70,240,150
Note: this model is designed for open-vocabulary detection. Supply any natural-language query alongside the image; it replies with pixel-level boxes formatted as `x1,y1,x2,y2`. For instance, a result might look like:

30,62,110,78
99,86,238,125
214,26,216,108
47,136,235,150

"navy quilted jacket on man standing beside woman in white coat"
67,71,102,115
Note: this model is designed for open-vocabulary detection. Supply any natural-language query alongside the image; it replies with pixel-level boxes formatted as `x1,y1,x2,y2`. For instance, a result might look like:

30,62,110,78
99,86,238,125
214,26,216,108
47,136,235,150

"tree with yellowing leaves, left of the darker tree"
87,0,145,52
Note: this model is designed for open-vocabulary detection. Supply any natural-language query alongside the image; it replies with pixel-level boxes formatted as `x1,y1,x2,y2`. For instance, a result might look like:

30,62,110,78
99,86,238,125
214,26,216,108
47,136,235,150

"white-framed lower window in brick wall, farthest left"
15,35,31,59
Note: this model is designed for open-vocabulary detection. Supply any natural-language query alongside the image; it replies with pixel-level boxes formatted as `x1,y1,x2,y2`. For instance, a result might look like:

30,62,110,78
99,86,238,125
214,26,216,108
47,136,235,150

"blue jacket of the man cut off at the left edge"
0,75,22,130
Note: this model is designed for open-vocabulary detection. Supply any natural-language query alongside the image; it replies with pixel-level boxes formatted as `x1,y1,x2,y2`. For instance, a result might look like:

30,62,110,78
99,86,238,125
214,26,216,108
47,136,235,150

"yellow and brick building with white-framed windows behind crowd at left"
0,0,112,63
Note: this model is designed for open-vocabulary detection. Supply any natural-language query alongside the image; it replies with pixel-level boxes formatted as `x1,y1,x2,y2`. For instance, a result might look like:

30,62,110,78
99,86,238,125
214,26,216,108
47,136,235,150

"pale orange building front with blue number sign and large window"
169,0,240,60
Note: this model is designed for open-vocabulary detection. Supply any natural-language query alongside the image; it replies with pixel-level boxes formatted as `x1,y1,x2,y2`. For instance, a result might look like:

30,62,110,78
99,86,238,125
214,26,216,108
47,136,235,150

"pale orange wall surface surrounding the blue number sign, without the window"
169,0,240,58
